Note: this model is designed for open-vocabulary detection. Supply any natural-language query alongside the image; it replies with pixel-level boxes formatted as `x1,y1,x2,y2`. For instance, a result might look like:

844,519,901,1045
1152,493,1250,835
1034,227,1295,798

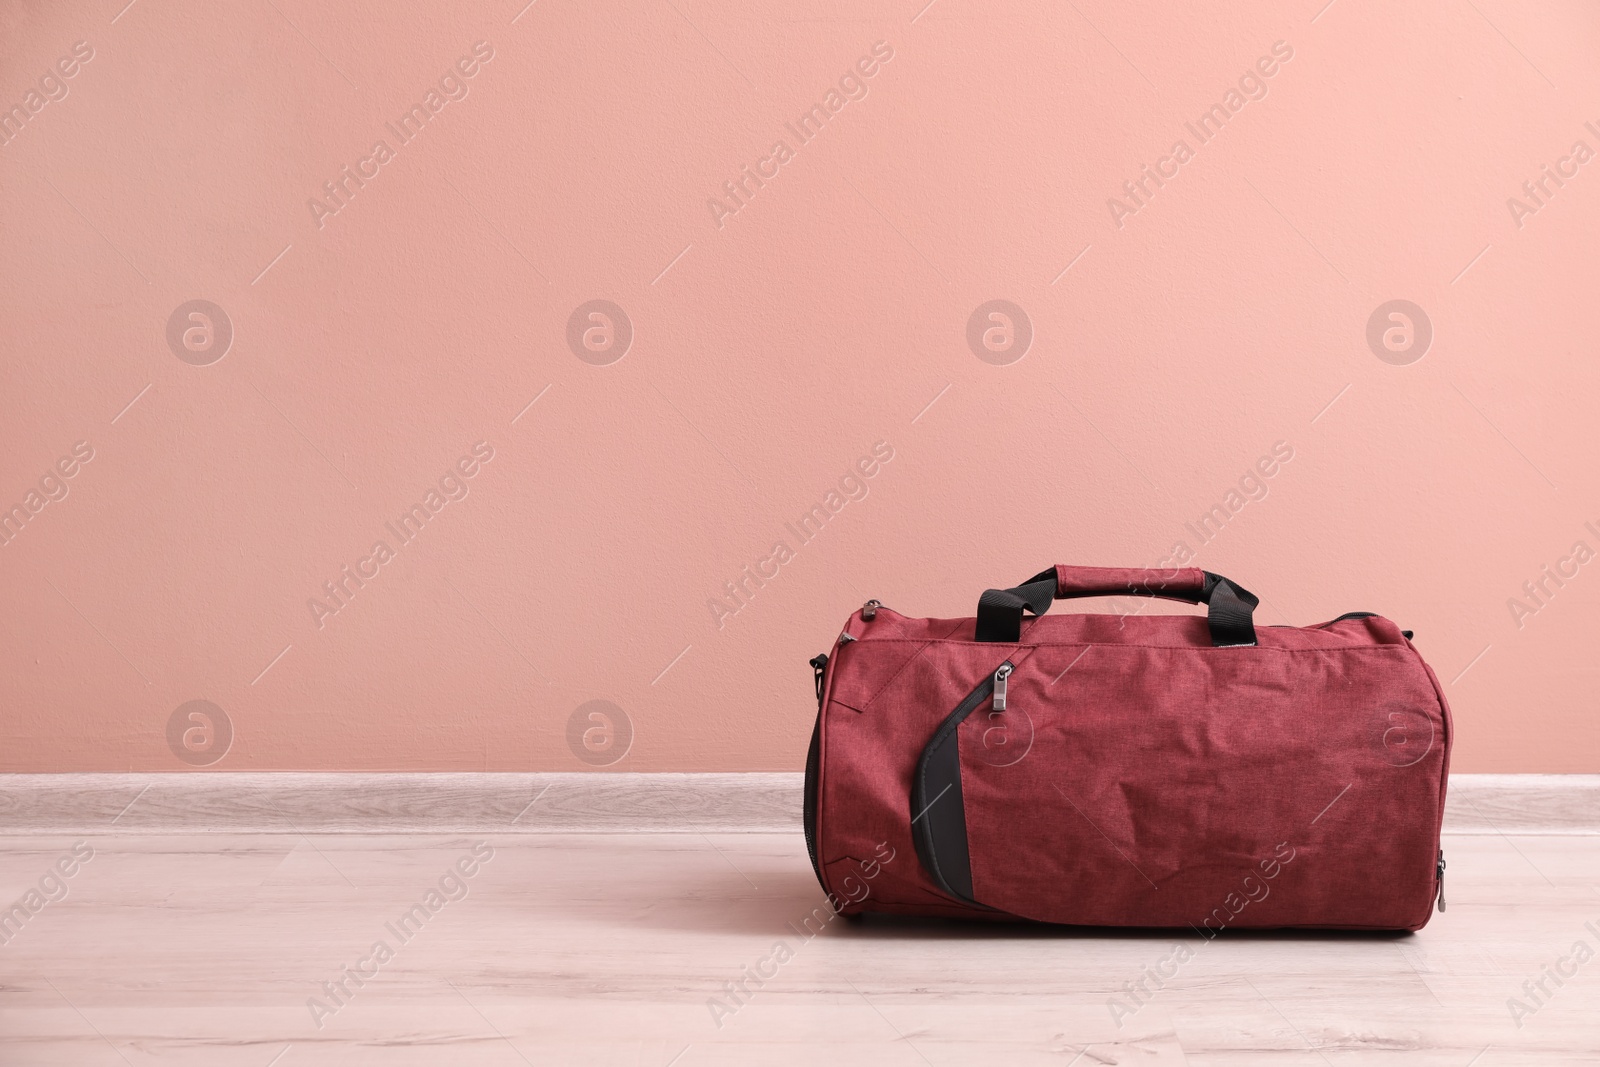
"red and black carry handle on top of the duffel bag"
976,563,1261,648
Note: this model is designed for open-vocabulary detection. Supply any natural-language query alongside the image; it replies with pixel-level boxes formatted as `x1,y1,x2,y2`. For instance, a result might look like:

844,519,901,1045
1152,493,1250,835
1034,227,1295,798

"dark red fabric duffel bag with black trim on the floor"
805,566,1451,936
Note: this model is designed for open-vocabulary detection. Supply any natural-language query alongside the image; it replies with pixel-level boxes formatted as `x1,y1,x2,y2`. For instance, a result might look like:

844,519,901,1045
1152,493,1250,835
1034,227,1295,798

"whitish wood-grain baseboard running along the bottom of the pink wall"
0,771,1600,835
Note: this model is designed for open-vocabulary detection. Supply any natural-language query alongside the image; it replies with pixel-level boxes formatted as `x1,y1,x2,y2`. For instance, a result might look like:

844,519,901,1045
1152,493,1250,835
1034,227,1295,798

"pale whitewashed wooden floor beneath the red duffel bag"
0,833,1600,1067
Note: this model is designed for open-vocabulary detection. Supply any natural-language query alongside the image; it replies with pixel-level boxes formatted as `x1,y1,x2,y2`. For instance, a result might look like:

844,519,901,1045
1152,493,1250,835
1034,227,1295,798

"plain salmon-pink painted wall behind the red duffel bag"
0,0,1600,771
